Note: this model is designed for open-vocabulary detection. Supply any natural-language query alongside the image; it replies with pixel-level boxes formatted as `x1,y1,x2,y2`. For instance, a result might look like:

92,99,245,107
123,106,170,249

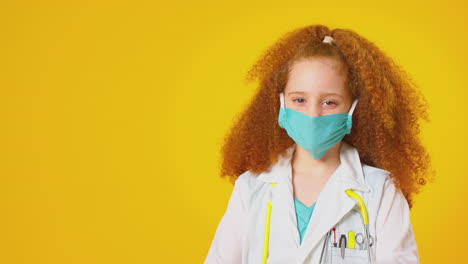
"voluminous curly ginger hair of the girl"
221,25,434,208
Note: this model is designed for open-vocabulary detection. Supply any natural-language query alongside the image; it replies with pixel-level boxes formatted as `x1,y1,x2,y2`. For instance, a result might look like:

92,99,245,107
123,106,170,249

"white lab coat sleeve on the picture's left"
204,178,246,264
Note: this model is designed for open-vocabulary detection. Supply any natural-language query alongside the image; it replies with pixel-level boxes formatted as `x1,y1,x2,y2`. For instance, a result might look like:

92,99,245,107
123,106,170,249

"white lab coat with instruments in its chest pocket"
204,141,419,264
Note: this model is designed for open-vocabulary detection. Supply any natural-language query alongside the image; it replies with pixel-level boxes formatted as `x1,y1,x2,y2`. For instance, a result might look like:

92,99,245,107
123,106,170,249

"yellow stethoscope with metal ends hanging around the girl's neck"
262,182,373,264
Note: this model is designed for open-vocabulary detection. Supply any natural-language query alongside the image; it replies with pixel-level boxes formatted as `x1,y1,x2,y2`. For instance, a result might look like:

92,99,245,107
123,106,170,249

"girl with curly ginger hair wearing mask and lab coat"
205,25,430,264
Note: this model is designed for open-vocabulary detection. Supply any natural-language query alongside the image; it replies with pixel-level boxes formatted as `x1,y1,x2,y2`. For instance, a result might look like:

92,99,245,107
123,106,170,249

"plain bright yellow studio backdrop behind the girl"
0,0,468,264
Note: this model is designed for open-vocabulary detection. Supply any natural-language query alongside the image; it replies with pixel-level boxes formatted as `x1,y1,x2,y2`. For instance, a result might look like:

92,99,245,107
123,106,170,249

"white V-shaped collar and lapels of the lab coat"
258,141,372,258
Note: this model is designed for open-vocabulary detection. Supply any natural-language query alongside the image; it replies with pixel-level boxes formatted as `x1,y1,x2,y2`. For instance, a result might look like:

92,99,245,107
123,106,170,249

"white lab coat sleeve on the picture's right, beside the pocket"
375,176,419,264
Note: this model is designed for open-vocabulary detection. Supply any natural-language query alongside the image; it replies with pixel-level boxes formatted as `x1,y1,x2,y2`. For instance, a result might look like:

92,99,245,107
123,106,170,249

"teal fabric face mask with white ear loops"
278,93,358,160
